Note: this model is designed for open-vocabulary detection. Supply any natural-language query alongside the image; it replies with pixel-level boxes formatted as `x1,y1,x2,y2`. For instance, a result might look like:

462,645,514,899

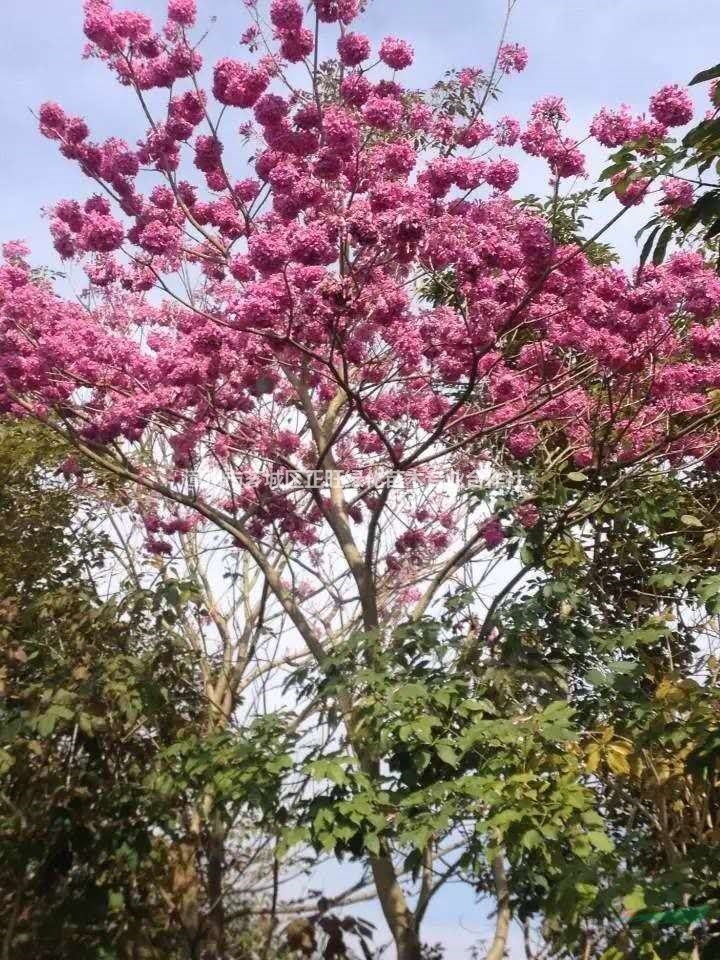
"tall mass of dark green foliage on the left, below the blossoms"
0,425,292,960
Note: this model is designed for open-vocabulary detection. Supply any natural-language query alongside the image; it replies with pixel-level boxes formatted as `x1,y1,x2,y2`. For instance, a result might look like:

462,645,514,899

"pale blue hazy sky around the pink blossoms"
0,0,720,960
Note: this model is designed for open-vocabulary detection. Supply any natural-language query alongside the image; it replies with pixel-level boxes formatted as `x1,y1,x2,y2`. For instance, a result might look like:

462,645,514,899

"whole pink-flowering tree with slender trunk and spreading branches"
0,0,720,960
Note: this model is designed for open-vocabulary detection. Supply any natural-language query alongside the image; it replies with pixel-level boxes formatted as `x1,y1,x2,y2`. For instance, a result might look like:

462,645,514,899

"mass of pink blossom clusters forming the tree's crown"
0,0,720,568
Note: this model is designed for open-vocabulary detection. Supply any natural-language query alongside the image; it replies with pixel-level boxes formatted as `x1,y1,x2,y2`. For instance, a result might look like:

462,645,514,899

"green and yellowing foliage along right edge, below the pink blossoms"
496,468,720,958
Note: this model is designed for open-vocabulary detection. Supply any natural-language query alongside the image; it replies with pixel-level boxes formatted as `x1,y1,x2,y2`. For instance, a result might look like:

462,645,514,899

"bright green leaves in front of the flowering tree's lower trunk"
294,615,609,892
